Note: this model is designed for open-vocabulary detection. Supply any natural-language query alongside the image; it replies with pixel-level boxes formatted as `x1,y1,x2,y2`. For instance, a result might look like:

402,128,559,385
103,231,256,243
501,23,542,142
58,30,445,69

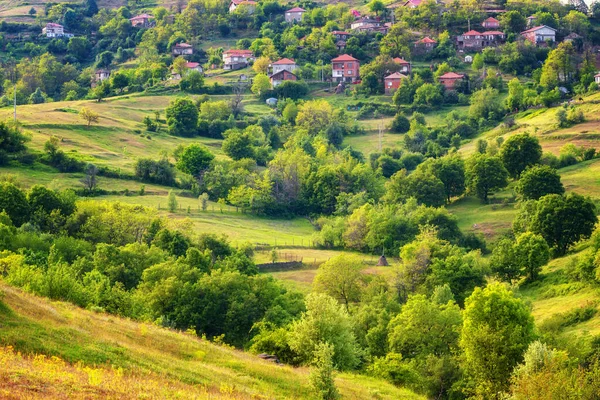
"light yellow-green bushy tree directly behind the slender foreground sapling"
289,293,362,370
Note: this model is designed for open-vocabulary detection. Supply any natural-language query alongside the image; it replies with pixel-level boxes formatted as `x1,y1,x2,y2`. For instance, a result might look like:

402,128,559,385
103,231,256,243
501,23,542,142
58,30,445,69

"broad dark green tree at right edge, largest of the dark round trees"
514,193,598,255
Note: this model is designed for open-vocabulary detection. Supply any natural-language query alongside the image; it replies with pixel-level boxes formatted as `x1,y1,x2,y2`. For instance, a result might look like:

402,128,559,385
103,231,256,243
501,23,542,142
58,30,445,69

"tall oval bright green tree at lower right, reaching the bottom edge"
460,283,535,399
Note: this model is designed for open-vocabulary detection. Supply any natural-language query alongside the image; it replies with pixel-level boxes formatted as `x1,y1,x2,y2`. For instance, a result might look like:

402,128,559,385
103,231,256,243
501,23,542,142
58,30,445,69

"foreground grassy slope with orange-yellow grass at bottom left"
0,284,421,399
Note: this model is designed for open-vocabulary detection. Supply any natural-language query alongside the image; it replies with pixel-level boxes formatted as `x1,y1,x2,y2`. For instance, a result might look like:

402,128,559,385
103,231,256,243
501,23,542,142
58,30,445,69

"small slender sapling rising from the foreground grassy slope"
308,343,340,400
